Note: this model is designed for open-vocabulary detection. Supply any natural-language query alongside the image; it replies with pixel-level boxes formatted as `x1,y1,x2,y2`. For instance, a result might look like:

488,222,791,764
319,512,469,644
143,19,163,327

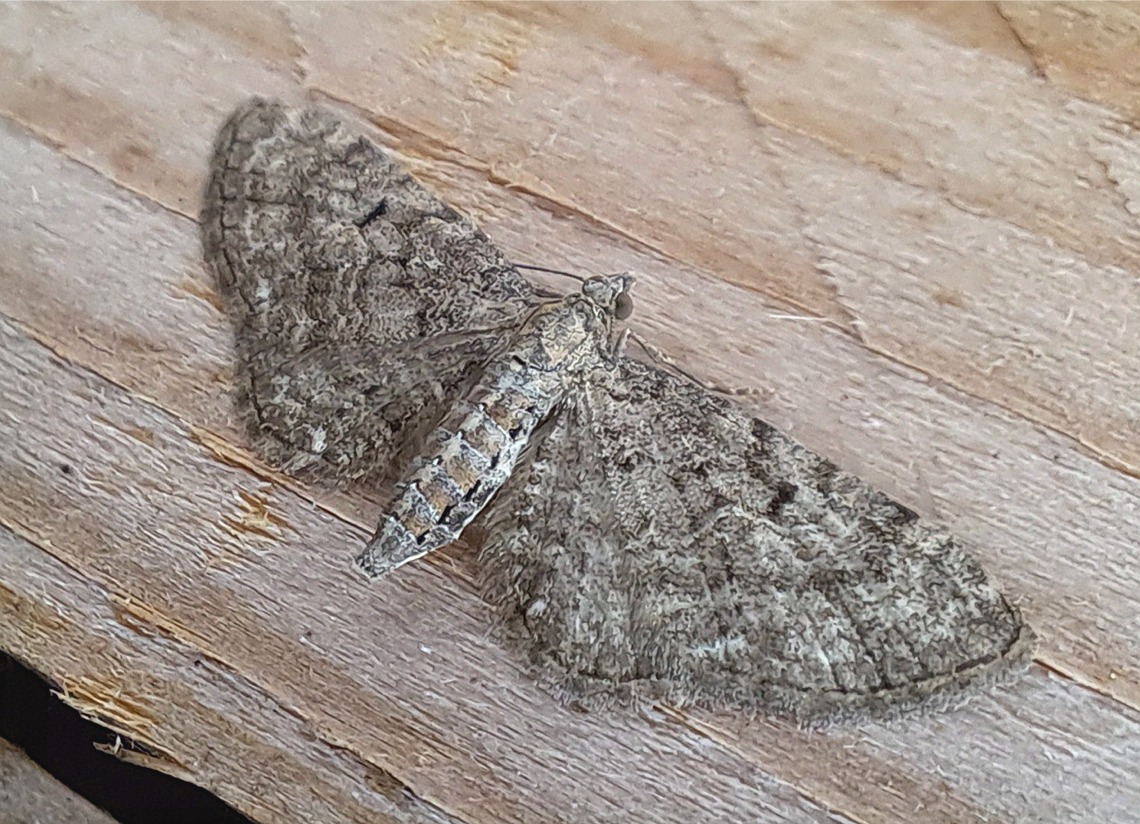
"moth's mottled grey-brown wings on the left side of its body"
202,99,537,479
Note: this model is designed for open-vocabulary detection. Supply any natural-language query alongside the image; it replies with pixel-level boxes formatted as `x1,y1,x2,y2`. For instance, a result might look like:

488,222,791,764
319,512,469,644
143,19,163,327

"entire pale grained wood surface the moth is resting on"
0,3,1140,822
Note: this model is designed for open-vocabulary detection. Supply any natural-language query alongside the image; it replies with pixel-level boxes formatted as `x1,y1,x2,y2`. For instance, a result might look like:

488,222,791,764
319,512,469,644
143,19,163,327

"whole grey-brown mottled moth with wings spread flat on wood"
202,99,1034,726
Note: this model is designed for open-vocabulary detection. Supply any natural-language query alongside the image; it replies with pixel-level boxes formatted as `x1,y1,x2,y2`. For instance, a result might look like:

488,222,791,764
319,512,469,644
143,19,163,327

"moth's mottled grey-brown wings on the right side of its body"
481,359,1033,726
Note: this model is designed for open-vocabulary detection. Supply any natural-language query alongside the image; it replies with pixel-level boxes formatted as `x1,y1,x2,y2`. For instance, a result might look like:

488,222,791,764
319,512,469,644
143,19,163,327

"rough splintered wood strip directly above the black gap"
0,528,455,824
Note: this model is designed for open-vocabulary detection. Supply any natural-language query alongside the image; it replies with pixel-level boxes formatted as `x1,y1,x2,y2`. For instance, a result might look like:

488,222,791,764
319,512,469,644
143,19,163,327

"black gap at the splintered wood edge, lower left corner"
0,651,250,824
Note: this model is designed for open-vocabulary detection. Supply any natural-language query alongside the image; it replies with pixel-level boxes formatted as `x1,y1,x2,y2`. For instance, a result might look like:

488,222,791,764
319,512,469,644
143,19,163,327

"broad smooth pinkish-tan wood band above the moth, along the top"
0,3,1140,472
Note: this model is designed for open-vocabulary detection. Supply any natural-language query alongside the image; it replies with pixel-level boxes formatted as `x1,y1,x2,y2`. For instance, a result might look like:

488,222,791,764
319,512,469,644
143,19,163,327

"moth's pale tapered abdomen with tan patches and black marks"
356,365,553,578
